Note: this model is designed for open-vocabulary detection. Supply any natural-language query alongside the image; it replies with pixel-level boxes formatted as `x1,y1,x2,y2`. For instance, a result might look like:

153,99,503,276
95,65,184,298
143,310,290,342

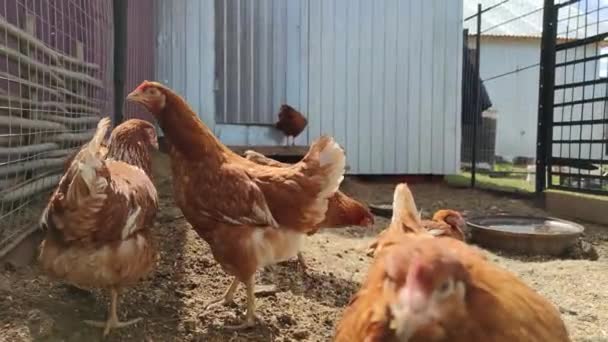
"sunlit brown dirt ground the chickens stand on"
0,153,608,342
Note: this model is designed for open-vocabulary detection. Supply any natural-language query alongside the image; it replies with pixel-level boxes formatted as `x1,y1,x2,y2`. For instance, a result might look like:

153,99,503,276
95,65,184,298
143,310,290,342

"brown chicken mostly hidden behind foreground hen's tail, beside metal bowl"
367,209,467,256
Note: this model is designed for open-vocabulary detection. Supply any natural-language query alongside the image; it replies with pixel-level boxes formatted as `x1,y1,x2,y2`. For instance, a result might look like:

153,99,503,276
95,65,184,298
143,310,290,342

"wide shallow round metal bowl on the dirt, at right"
467,215,585,256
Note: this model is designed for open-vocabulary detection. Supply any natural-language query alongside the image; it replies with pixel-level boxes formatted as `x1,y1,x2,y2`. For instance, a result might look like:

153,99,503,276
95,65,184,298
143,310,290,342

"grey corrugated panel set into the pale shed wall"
215,0,293,124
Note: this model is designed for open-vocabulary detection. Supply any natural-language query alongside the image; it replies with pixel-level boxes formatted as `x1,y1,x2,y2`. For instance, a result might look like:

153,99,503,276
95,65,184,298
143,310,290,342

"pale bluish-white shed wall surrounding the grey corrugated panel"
157,0,462,174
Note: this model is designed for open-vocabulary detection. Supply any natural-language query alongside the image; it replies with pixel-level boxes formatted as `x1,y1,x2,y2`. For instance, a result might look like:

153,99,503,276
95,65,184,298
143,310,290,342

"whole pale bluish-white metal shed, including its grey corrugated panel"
156,0,462,174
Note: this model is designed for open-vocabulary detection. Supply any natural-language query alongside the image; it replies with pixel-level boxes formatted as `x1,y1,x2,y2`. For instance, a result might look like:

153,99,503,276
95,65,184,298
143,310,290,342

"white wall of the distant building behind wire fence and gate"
478,37,606,159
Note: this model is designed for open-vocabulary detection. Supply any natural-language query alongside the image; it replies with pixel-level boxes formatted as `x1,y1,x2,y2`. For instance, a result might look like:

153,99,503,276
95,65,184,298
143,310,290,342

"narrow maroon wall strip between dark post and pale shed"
122,0,156,120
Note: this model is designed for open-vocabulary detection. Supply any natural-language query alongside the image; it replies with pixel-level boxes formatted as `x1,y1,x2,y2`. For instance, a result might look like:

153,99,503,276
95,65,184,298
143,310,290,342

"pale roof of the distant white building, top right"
463,0,608,39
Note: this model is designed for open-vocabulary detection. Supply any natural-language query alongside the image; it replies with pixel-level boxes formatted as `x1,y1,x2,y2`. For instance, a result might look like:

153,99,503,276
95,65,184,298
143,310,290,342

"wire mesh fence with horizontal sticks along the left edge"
0,0,113,256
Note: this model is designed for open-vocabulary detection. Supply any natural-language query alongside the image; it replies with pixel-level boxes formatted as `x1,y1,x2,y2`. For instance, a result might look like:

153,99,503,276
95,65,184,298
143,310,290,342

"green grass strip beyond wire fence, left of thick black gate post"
444,172,534,193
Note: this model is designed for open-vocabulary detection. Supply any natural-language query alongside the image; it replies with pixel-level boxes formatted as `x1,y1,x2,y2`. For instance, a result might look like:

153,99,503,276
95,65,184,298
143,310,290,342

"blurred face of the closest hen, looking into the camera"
384,239,468,341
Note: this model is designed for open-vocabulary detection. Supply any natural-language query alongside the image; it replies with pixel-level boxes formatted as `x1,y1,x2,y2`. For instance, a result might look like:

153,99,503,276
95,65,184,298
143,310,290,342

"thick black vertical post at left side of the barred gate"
535,0,557,194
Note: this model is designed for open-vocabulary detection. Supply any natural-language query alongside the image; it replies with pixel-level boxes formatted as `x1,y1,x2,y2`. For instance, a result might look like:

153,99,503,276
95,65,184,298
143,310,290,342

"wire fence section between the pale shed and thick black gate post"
461,0,544,192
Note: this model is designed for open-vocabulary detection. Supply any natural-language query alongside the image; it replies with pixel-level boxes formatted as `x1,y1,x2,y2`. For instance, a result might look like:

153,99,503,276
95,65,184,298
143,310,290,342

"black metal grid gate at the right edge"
536,0,608,195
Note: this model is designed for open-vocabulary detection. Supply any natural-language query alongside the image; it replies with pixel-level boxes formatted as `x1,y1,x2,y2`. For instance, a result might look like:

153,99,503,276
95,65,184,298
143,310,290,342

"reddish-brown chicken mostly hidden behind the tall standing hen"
245,150,374,270
